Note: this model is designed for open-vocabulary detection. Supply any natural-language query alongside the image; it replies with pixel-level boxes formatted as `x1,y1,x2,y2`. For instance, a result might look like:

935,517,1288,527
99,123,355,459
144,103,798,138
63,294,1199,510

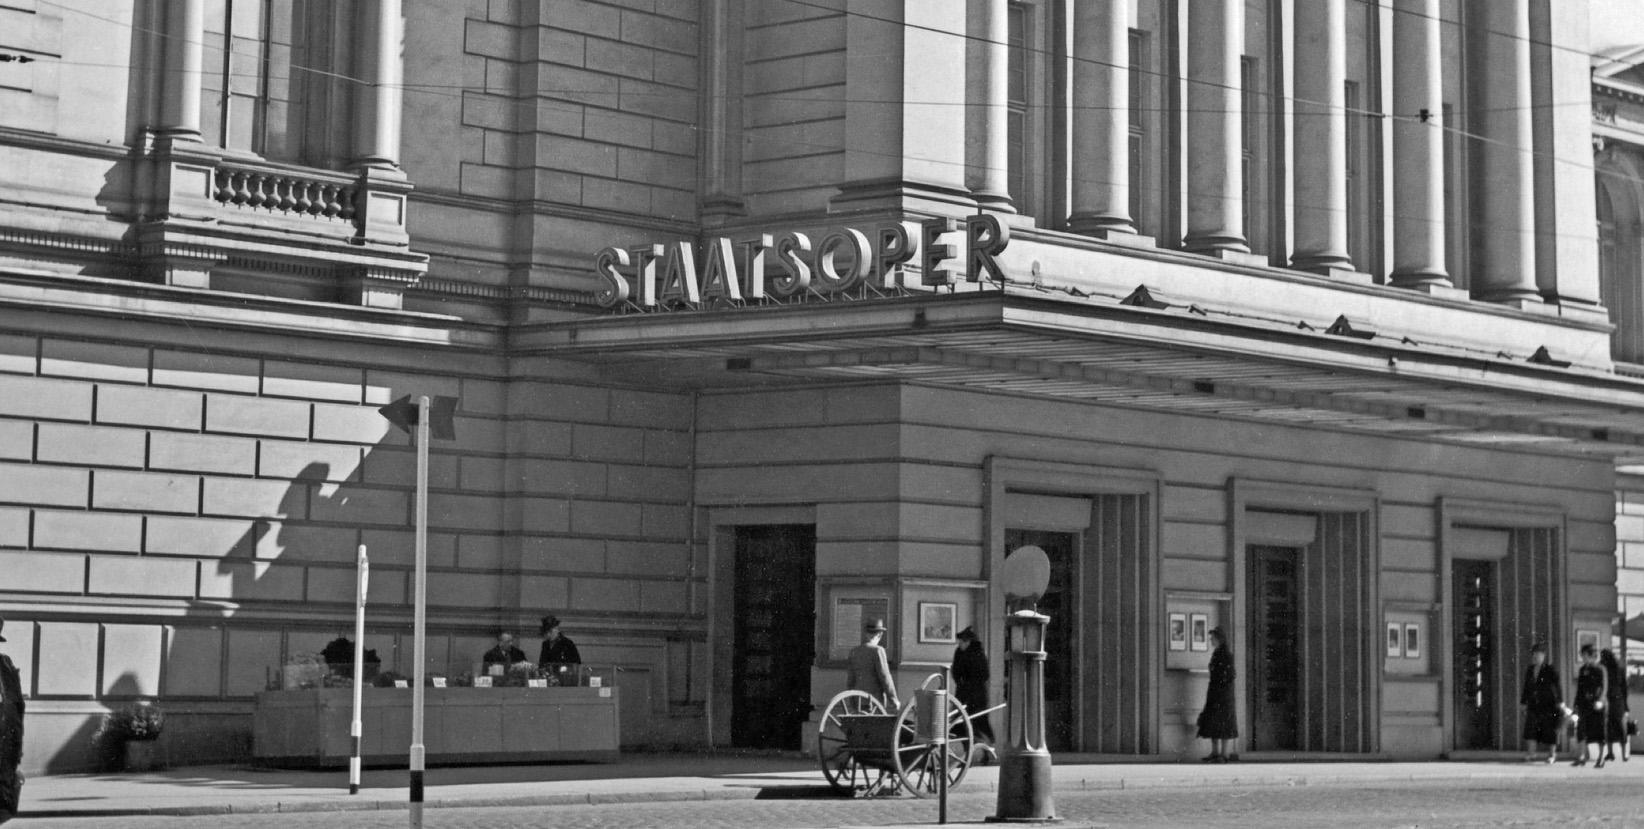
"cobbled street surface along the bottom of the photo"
19,771,1644,829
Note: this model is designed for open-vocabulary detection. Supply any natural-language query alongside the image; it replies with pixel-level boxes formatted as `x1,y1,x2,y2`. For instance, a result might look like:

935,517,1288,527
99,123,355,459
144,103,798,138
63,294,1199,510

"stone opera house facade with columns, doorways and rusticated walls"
0,0,1644,771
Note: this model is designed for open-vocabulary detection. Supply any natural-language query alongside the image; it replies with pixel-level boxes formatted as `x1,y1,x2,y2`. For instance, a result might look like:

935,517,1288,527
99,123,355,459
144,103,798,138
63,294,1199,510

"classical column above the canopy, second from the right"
1392,0,1450,288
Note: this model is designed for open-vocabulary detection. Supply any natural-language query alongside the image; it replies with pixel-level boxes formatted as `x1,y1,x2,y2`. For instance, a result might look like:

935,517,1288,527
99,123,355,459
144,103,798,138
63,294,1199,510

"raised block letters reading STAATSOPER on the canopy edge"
593,214,1011,311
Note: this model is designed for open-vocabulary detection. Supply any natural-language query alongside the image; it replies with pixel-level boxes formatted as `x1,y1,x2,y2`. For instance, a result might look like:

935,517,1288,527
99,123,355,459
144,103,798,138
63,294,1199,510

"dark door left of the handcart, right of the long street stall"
730,525,817,750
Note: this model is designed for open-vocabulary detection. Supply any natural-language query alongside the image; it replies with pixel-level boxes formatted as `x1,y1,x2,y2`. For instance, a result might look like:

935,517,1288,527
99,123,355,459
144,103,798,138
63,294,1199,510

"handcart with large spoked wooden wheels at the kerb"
817,674,993,798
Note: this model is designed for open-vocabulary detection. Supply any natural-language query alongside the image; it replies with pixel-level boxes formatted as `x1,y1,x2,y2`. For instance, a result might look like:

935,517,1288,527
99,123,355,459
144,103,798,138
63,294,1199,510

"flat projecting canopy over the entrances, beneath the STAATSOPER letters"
516,293,1644,462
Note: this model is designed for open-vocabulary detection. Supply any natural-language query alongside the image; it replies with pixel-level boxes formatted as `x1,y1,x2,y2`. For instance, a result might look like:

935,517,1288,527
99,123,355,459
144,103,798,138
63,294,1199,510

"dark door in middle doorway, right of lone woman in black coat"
1249,546,1302,752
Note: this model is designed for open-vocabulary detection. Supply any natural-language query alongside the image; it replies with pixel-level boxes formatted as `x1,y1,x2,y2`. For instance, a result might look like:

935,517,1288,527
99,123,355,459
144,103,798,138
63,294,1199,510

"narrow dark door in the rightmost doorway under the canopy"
1450,559,1499,748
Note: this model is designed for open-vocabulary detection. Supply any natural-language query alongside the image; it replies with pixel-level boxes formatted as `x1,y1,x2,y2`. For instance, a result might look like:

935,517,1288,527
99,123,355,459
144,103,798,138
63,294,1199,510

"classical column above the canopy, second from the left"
1067,0,1136,234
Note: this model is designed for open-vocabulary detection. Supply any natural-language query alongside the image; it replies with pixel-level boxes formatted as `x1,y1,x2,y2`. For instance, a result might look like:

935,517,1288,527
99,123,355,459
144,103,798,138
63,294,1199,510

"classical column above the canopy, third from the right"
1291,0,1353,273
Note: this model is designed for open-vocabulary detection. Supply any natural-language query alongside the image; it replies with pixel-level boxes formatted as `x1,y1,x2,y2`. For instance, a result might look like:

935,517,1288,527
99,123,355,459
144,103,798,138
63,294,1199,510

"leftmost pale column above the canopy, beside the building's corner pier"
965,0,1016,212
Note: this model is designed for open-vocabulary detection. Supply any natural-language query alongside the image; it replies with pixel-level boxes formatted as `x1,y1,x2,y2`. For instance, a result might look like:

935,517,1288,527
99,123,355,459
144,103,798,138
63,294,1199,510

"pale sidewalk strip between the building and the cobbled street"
20,753,1644,817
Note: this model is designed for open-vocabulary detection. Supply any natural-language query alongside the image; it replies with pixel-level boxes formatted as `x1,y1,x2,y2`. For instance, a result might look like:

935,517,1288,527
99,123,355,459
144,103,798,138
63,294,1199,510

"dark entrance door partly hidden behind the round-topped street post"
996,530,1080,752
